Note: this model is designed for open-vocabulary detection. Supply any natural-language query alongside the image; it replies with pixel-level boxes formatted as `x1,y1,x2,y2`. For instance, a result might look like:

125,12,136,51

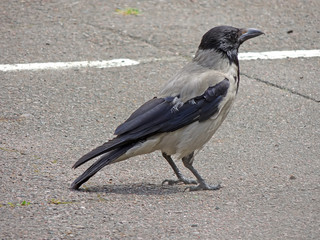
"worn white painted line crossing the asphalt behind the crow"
0,49,320,72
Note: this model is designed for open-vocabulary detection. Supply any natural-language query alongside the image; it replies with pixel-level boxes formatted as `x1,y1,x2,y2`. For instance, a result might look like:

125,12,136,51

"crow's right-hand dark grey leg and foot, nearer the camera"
182,153,221,191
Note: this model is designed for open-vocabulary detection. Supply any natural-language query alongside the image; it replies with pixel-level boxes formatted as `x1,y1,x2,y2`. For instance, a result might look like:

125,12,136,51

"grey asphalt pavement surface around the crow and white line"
0,0,320,239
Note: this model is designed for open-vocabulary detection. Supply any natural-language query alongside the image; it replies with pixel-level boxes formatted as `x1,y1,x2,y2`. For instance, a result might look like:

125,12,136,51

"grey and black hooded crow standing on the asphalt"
71,26,263,191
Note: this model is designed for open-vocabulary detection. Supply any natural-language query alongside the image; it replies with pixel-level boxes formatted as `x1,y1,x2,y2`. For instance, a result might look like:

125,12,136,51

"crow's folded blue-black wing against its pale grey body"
115,79,229,137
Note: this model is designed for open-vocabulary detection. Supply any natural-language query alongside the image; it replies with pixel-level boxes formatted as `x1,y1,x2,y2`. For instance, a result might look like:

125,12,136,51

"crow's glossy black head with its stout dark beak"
199,26,263,54
